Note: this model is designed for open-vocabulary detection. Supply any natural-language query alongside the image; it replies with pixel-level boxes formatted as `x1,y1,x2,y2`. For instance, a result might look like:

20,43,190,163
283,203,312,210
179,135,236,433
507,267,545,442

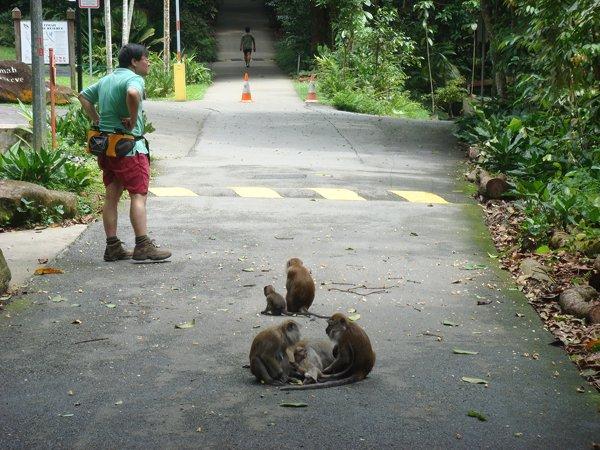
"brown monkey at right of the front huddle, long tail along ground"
281,313,375,391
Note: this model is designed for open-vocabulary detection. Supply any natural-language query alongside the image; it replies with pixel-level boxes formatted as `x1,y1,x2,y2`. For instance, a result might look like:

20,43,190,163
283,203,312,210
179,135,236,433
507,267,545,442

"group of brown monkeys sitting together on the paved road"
250,258,375,390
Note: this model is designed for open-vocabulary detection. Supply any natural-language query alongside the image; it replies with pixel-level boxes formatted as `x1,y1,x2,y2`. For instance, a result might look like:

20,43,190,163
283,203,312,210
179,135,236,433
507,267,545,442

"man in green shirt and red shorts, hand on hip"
79,44,171,261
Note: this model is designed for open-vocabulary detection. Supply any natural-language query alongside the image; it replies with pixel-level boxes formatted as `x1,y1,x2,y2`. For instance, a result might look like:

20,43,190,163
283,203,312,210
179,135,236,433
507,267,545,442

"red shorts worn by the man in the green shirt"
98,153,150,195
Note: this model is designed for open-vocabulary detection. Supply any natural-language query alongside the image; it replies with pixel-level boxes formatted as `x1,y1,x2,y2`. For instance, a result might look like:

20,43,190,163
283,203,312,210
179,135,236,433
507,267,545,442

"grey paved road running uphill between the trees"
0,0,600,448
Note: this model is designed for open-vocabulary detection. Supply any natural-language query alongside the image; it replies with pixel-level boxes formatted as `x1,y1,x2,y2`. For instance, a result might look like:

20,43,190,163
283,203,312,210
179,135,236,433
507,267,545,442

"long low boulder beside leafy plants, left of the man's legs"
0,180,77,225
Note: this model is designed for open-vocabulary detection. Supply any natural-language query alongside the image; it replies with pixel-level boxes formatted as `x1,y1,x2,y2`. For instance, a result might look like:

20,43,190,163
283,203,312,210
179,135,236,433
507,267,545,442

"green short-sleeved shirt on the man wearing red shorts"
81,67,148,156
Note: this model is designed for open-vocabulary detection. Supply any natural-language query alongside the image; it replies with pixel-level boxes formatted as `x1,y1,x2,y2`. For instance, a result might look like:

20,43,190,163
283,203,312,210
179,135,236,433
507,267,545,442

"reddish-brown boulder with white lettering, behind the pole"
0,60,76,105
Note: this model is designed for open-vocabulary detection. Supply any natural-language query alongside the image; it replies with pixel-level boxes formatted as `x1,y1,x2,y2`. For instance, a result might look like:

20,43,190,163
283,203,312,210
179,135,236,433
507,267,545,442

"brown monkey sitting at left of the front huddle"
250,320,300,385
